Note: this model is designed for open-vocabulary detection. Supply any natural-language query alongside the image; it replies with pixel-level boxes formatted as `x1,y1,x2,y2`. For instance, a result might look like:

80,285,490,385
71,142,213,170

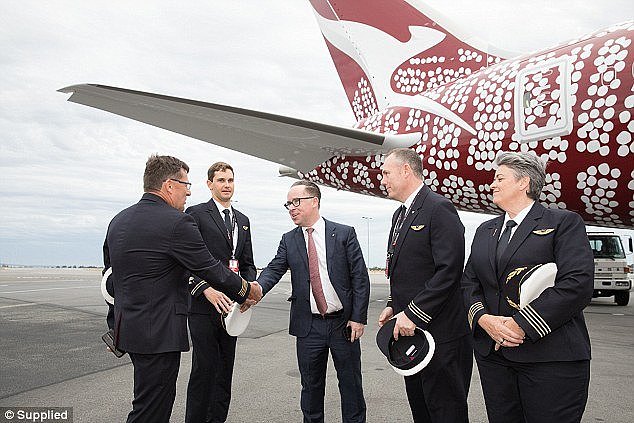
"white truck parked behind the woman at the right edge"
588,232,632,306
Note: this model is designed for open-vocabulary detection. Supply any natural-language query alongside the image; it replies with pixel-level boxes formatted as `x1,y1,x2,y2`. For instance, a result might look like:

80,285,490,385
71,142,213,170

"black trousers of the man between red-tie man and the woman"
405,335,473,423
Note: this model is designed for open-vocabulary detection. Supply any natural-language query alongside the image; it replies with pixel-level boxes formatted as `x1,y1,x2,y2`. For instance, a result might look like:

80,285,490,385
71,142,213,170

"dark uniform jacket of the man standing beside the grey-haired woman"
387,185,469,342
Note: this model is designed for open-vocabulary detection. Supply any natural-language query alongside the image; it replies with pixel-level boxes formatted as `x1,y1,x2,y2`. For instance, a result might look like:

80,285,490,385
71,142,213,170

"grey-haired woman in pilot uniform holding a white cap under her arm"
462,153,594,423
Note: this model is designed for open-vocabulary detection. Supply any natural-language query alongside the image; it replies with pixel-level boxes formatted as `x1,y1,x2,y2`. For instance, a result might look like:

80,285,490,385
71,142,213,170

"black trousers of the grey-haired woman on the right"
475,352,590,423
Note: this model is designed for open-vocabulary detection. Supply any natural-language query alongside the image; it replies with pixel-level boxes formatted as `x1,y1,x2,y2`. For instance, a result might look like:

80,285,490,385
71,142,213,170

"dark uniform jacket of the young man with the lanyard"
185,199,257,314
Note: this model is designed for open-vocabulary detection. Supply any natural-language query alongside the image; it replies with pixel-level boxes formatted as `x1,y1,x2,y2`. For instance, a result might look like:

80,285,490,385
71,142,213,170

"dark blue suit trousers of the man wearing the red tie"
296,317,366,423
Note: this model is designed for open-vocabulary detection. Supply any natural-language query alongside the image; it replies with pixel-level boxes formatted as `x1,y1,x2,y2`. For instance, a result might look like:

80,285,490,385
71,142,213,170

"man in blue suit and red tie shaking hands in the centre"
253,181,370,423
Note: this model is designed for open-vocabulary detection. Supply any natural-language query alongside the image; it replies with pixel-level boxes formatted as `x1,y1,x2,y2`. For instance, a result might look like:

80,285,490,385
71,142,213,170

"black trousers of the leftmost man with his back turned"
127,351,181,423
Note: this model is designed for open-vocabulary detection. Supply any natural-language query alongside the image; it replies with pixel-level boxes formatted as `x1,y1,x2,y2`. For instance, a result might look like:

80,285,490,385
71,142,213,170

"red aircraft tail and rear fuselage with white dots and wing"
60,0,634,228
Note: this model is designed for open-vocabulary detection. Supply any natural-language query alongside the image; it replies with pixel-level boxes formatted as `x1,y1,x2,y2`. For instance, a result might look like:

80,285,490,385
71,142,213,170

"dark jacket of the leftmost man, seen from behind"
104,193,250,354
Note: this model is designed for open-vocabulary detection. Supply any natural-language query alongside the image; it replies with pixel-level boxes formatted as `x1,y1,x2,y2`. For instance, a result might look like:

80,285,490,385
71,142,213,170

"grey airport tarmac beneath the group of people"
0,268,634,423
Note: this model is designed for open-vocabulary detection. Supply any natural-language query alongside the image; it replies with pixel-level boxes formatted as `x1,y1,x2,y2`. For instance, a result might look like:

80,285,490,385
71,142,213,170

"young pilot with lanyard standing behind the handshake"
185,162,257,423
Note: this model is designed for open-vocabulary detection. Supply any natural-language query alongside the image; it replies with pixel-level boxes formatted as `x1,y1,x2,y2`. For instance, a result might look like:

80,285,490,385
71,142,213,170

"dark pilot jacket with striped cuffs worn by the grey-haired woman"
462,203,594,362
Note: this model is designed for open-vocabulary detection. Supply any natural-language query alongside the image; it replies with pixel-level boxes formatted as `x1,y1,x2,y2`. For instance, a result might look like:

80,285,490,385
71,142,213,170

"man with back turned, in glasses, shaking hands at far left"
104,156,261,423
